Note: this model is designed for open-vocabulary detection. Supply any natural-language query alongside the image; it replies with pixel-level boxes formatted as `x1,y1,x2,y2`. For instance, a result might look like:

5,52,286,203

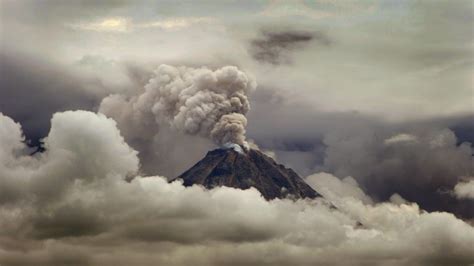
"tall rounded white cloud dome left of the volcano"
44,111,139,178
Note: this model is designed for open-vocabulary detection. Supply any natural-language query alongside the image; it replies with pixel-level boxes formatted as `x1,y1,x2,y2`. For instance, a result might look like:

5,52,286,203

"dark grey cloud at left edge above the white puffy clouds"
0,51,100,144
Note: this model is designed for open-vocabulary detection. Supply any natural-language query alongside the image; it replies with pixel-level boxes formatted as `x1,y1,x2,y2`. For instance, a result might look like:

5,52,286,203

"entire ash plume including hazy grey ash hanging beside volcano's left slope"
99,65,256,178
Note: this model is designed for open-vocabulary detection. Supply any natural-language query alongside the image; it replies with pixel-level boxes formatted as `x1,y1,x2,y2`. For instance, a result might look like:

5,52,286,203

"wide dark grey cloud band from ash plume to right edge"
248,93,474,218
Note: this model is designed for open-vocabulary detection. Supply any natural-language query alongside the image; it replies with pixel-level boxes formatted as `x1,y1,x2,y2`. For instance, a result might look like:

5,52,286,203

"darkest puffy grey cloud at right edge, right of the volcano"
324,129,474,217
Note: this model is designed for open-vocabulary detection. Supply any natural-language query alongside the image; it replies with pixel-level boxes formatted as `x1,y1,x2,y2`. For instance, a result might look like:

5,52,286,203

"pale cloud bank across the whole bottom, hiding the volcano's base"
0,111,474,265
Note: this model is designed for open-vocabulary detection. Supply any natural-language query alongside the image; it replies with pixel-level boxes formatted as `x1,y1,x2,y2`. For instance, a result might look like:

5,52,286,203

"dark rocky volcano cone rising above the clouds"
171,144,320,200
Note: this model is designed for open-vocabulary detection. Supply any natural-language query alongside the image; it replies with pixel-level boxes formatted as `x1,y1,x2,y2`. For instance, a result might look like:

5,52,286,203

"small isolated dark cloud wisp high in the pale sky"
250,31,331,65
